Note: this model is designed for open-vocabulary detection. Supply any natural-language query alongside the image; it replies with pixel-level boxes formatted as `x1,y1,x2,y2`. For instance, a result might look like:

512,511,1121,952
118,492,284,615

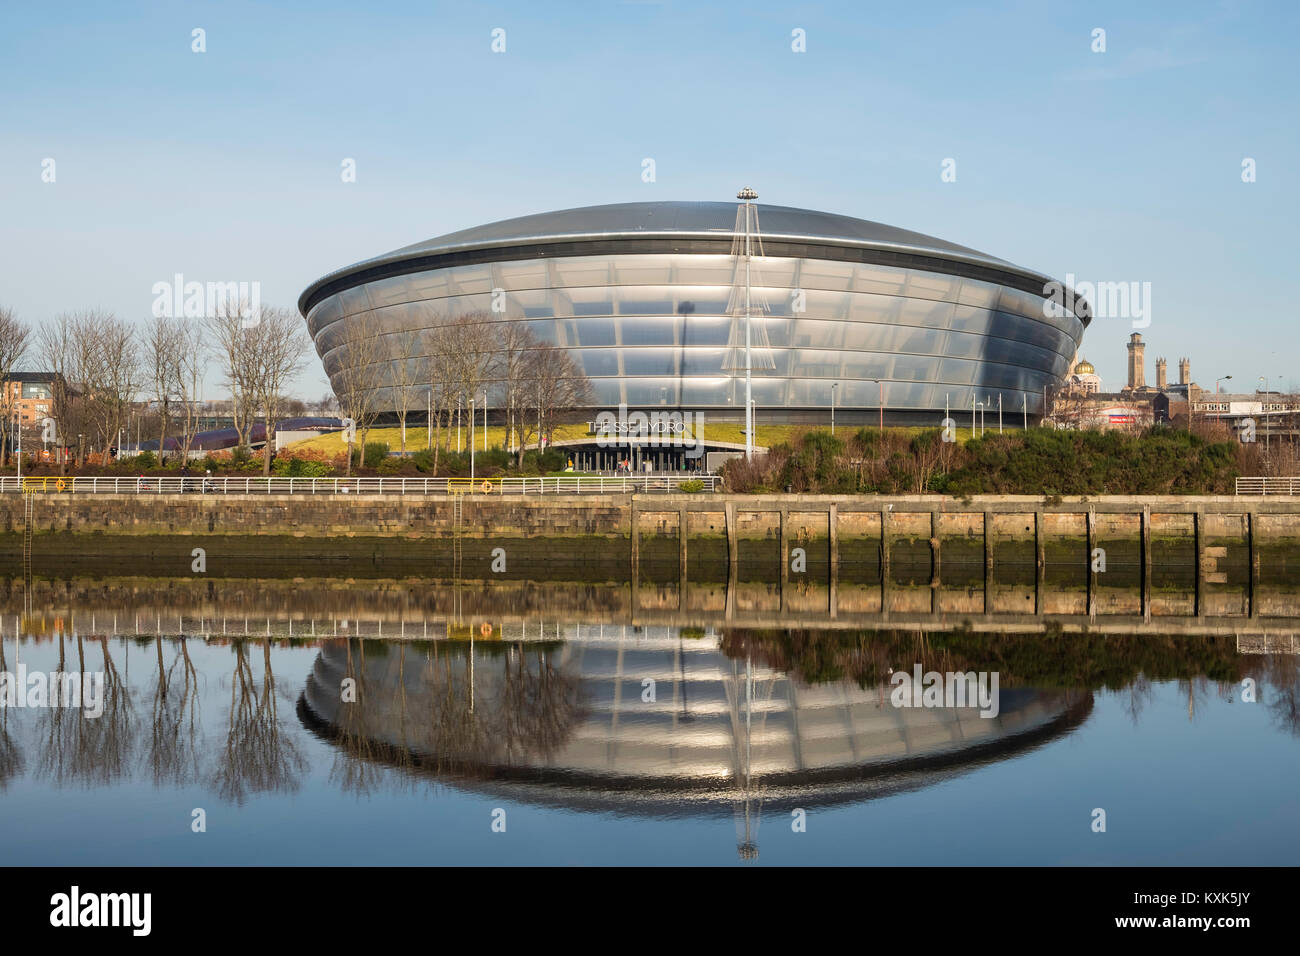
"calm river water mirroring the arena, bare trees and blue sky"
0,579,1300,865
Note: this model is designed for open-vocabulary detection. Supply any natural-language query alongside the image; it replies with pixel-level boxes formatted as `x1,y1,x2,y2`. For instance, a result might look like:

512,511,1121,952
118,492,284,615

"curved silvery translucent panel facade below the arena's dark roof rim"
307,208,1084,419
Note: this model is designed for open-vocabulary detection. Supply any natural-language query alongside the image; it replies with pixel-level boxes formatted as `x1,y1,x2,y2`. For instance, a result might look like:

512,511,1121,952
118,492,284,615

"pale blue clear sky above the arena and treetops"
0,0,1300,398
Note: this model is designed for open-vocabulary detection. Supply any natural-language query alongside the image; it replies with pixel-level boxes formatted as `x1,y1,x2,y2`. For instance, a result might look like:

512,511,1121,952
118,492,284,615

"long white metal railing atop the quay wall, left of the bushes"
0,475,718,496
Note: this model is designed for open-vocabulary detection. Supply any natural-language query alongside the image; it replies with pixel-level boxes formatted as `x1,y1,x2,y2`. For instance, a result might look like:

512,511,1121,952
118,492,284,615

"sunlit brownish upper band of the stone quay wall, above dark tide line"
0,494,1300,542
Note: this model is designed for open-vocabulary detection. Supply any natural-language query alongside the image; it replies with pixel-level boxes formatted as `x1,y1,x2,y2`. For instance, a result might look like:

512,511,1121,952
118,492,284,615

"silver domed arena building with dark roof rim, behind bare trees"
299,202,1088,444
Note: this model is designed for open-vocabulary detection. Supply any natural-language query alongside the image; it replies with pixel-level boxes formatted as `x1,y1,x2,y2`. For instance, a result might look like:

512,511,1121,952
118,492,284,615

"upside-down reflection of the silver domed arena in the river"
299,626,1092,858
